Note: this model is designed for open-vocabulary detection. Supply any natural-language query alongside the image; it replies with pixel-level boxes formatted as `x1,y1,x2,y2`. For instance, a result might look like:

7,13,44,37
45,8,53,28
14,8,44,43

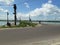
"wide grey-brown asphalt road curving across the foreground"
0,25,60,45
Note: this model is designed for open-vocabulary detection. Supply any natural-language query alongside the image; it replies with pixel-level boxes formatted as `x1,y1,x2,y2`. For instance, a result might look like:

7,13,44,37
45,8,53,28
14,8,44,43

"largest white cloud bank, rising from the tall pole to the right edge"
18,3,60,17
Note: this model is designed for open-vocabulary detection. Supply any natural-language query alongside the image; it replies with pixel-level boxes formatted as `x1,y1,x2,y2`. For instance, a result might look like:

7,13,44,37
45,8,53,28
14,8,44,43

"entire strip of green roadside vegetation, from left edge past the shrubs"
0,21,37,28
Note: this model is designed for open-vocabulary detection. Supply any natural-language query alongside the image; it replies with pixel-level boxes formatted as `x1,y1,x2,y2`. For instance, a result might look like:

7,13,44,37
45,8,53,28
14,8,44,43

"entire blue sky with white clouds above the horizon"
0,0,60,20
